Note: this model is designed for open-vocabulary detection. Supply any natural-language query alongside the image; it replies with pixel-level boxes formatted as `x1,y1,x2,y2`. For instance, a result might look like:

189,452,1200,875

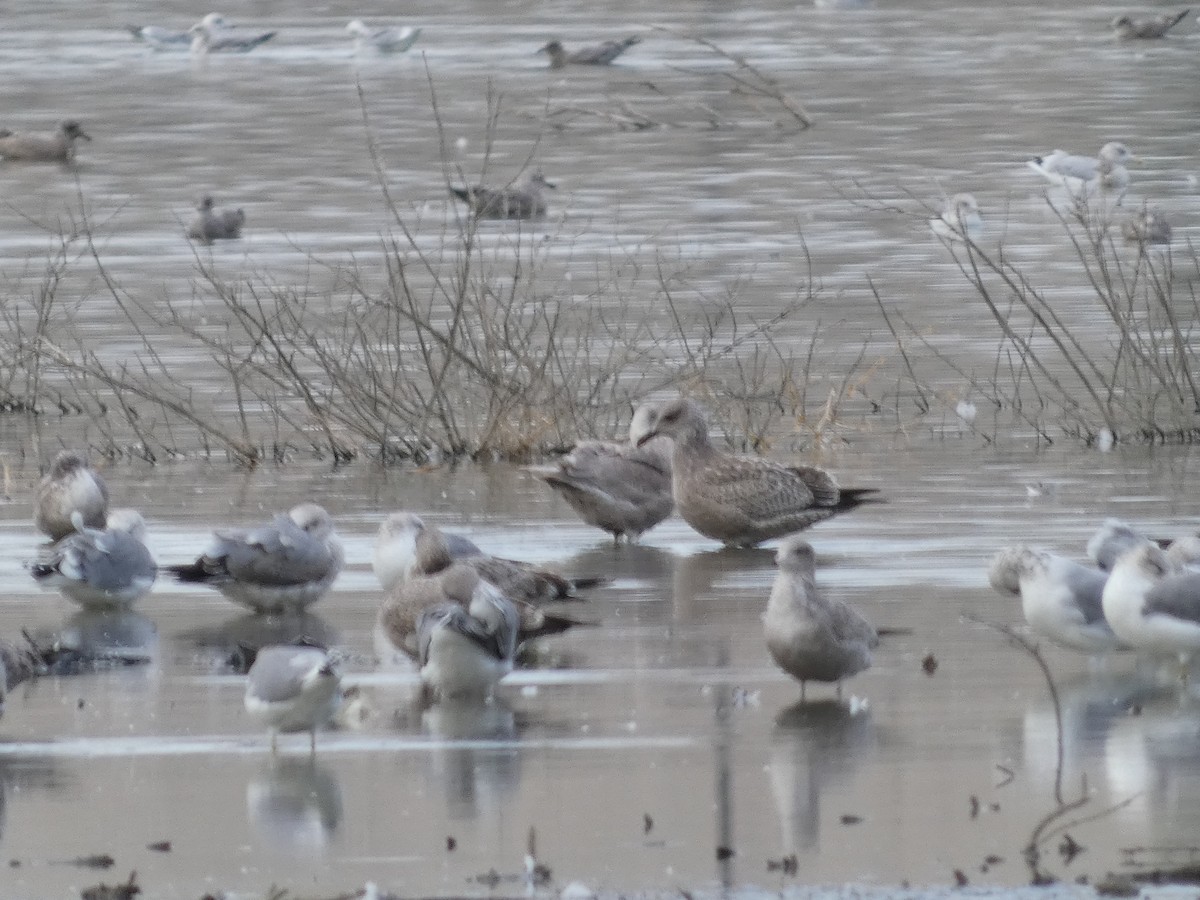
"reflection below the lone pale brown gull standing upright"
767,700,878,854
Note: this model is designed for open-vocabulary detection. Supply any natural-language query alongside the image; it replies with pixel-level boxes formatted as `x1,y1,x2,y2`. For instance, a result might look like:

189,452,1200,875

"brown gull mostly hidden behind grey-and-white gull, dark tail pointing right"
378,562,578,660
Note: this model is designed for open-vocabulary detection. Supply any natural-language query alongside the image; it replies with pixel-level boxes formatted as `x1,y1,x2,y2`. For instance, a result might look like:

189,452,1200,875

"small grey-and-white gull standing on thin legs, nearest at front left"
245,644,342,754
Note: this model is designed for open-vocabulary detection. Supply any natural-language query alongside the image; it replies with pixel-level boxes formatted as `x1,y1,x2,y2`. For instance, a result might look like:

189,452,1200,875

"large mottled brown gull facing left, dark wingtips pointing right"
631,397,877,547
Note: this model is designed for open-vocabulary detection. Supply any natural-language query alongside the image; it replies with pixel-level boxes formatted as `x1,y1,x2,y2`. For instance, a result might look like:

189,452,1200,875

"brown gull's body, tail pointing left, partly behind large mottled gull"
527,410,674,544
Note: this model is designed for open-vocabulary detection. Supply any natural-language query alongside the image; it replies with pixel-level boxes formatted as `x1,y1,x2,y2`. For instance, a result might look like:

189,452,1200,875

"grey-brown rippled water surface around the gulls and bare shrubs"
0,0,1200,898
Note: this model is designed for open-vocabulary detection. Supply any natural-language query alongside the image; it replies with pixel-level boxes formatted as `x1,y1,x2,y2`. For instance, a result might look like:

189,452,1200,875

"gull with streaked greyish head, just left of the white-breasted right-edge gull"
988,546,1128,653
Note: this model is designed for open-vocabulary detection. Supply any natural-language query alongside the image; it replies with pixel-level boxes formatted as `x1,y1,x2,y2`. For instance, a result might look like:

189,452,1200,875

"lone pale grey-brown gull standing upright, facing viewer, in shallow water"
762,535,880,700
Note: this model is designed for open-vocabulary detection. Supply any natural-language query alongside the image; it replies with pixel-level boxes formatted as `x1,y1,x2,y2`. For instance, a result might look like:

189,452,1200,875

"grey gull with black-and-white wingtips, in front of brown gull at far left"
30,509,157,610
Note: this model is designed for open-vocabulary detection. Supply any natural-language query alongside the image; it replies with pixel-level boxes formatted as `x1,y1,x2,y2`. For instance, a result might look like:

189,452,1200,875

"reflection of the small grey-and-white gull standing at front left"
246,756,342,857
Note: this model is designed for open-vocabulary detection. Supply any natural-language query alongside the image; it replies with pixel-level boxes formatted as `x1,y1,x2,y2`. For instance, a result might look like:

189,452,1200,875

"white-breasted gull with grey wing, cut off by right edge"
1103,544,1200,672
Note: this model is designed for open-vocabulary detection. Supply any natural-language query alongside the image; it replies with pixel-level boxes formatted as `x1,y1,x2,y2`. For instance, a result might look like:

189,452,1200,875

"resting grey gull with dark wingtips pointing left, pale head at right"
167,503,344,613
